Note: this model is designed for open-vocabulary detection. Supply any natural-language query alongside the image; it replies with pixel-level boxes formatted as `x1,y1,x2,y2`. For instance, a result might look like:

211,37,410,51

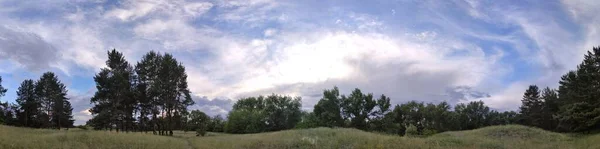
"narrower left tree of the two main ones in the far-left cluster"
15,80,42,128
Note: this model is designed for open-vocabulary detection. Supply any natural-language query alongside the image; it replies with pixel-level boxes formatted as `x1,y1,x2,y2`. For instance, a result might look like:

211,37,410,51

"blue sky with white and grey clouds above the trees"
0,0,600,124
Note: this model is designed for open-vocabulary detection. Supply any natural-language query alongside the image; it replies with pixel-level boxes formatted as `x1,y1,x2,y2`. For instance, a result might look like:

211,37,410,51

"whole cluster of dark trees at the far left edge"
0,72,74,129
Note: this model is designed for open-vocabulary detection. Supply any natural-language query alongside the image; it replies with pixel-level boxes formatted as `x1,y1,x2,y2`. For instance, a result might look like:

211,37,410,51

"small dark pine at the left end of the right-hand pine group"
519,85,544,127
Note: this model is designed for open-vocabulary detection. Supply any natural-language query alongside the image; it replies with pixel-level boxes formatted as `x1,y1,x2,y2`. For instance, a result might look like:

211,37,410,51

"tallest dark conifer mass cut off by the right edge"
556,47,600,132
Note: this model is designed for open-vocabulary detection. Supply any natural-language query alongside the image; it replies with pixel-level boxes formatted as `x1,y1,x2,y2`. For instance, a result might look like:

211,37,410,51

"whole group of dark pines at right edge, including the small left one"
519,47,600,132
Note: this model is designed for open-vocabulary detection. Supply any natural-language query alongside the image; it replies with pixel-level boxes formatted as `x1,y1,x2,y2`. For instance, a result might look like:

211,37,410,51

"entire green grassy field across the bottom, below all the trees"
0,125,600,149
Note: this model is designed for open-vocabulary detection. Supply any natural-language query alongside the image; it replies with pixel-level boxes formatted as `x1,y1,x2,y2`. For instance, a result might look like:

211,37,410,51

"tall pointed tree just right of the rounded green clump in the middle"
313,87,344,127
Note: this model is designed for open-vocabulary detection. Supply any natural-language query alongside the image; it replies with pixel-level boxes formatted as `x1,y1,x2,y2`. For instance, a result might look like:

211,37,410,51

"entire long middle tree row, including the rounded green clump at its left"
213,87,517,135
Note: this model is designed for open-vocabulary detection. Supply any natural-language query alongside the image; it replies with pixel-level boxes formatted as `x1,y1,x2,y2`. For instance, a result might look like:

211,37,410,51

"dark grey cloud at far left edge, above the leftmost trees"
0,26,58,70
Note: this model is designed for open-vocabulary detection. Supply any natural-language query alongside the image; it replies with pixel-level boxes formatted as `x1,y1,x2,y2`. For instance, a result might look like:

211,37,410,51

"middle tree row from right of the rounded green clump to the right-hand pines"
298,87,517,135
